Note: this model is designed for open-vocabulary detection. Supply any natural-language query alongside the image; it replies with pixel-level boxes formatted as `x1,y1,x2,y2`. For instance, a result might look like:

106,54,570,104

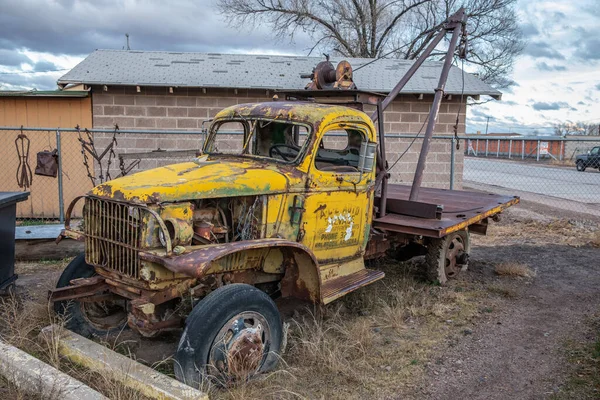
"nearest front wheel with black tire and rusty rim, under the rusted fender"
174,283,282,386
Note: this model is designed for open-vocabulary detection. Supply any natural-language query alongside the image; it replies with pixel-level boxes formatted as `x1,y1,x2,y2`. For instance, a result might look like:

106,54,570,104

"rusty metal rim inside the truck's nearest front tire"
208,311,271,379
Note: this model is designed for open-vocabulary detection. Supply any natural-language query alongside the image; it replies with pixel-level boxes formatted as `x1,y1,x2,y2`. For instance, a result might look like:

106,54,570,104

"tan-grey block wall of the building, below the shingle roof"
92,87,466,188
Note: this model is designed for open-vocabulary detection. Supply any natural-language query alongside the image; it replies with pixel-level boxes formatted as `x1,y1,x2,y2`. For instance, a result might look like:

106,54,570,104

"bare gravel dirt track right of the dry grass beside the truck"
424,205,600,399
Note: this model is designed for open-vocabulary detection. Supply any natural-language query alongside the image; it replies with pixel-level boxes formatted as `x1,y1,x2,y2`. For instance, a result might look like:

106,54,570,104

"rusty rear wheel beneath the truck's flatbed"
425,231,471,285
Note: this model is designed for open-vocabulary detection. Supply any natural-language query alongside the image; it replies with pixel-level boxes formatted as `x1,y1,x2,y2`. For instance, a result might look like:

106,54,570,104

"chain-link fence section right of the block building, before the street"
463,135,600,215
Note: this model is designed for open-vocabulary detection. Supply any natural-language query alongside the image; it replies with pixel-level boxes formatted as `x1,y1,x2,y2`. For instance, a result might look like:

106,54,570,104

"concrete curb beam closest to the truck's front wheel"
42,325,208,400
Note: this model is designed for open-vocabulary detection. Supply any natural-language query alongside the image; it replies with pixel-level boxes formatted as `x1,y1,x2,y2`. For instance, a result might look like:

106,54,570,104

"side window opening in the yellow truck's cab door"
315,128,367,173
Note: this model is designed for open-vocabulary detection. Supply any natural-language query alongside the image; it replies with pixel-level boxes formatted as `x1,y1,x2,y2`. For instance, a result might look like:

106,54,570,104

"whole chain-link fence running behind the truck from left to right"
0,127,600,225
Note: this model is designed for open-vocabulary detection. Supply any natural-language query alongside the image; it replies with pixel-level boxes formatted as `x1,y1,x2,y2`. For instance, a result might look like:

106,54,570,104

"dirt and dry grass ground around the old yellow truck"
0,204,600,399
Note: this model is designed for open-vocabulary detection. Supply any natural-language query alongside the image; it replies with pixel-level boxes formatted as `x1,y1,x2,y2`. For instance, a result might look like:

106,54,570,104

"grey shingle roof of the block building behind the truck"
58,50,501,97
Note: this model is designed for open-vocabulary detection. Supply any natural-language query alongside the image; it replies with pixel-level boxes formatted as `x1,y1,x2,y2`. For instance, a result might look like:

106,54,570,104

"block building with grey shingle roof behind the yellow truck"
58,50,501,188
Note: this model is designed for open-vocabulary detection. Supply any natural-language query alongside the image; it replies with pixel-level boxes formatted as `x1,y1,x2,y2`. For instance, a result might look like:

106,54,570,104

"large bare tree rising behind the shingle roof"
217,0,524,88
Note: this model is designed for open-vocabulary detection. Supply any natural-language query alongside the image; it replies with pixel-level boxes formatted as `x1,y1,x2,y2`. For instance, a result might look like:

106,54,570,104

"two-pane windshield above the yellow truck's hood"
204,118,310,163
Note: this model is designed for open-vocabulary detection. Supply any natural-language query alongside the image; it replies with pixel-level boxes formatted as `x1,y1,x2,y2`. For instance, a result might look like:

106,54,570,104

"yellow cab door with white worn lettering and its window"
301,123,375,265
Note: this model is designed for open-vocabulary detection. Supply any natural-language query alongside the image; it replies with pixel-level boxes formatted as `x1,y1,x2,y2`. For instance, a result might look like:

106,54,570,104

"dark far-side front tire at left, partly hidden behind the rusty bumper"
54,253,127,338
